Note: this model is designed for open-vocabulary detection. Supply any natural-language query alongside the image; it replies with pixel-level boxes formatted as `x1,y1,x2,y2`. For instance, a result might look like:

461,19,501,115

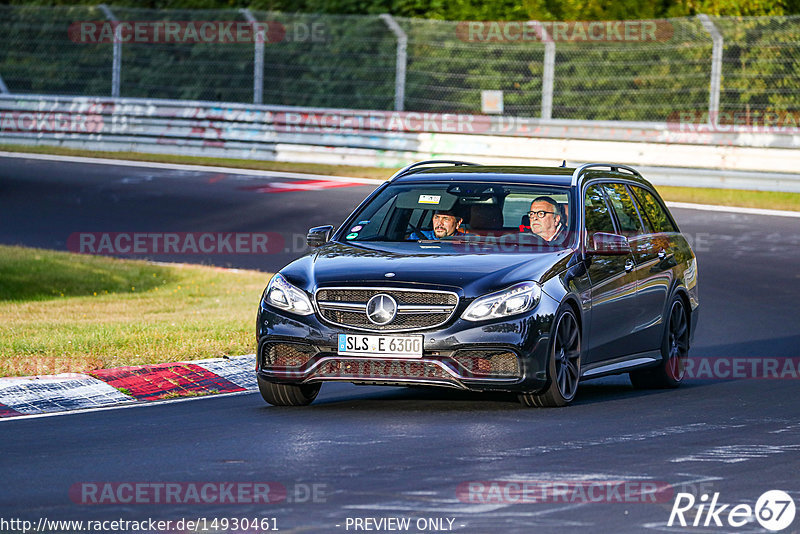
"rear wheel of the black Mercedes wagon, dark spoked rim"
630,296,689,389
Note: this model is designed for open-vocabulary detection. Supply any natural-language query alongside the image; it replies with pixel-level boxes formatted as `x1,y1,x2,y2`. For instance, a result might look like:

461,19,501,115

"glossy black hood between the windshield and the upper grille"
281,242,574,297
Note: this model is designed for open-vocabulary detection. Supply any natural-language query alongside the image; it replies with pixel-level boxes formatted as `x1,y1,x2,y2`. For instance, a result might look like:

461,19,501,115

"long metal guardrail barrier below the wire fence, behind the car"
0,95,800,192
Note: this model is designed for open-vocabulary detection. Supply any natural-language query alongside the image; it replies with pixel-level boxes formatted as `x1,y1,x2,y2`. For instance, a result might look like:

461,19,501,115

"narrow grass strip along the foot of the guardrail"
0,145,800,211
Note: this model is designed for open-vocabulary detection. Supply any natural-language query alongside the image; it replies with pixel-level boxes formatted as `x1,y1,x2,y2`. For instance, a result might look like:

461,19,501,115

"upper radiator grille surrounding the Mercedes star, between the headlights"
315,288,458,332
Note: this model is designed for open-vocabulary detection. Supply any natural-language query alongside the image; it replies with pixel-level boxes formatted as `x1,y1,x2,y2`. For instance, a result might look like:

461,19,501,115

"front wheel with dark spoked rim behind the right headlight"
519,309,581,408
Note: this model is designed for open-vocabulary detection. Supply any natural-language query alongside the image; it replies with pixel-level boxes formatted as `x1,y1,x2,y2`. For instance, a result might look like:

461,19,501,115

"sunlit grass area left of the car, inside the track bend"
0,246,269,376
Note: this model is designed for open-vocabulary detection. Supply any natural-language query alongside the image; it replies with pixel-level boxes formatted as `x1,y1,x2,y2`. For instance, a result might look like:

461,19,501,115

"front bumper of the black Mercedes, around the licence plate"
256,295,558,392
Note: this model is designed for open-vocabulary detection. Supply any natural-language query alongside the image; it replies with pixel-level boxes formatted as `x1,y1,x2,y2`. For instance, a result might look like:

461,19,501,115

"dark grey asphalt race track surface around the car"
0,153,800,533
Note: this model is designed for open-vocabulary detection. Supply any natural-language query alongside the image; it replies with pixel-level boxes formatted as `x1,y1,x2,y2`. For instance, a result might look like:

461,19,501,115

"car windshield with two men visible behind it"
340,182,574,246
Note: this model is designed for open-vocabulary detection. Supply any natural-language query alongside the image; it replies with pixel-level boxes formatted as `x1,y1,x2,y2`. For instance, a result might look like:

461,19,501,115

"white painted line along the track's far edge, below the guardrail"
0,151,800,218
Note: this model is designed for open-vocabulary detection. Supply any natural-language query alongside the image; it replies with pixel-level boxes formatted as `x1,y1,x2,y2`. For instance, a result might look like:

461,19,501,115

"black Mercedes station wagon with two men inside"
256,161,698,406
